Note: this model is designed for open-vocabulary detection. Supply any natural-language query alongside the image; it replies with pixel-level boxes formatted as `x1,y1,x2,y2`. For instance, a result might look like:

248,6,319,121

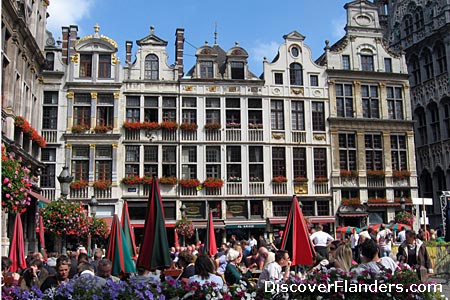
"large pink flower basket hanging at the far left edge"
2,144,31,213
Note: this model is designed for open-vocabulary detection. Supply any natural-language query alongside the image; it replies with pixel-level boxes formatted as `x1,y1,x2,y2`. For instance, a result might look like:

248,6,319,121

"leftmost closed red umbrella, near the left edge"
9,213,27,272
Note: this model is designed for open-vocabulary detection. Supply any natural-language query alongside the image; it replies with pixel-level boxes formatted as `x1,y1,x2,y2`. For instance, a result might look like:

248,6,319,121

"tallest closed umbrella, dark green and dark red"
136,177,171,270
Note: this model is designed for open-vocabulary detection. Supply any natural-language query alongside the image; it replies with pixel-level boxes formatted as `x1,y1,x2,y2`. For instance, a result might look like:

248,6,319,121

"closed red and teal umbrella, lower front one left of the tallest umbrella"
106,214,136,276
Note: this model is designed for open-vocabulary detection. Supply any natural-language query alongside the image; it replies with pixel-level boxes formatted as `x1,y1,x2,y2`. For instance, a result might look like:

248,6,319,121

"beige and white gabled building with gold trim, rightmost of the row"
318,1,417,227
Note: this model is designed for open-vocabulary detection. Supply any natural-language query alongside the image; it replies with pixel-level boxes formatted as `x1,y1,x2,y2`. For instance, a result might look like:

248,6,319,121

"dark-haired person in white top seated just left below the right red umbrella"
257,250,291,288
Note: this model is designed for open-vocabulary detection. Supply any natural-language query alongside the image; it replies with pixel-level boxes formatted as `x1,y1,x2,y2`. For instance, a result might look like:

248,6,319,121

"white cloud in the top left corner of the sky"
47,0,95,38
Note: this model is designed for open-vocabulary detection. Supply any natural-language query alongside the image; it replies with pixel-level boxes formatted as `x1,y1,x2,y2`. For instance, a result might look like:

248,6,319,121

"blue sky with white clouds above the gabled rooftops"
47,0,349,75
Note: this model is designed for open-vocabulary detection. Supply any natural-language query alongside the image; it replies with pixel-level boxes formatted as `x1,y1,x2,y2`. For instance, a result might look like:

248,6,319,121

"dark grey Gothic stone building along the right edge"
375,0,450,228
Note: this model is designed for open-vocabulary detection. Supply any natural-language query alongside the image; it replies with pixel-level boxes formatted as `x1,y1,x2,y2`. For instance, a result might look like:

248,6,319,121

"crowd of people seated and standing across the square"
2,225,433,291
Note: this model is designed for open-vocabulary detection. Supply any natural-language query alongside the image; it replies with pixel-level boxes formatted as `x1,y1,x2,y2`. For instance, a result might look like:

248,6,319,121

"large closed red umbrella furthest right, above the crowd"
281,195,315,266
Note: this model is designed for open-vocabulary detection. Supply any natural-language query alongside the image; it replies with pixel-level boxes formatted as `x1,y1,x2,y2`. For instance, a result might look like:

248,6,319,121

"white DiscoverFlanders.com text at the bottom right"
264,280,442,293
